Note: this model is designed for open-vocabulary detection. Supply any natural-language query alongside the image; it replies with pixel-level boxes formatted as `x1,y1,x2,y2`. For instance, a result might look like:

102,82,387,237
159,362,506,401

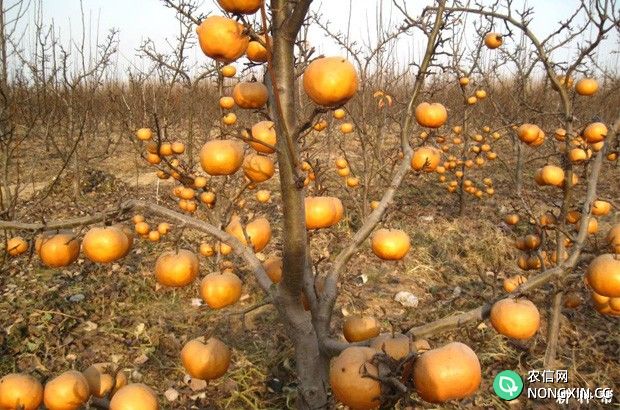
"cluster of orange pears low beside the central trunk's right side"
329,315,482,410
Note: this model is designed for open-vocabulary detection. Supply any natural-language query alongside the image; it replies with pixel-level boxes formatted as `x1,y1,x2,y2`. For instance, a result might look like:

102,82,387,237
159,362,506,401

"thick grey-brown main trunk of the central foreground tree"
267,0,328,409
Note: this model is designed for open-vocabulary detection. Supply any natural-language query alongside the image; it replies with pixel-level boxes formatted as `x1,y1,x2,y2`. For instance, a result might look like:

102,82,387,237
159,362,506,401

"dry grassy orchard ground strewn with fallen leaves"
0,134,620,409
